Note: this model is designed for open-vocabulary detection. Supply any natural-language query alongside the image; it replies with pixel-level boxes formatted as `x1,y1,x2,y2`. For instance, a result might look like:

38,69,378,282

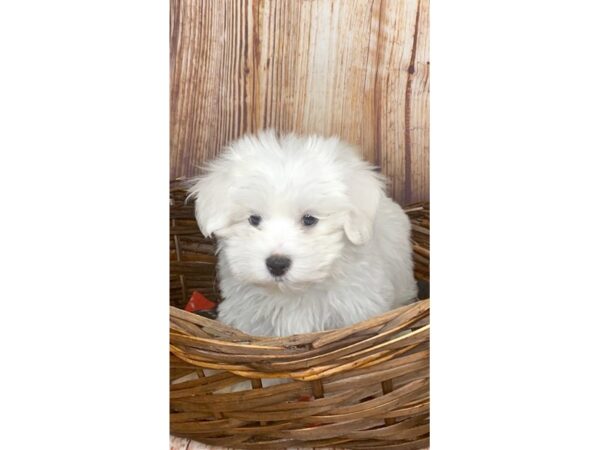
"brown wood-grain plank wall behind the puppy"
170,0,429,204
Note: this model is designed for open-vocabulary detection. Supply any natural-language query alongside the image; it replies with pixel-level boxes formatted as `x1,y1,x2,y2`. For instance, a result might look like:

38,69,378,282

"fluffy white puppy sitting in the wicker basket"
190,131,417,336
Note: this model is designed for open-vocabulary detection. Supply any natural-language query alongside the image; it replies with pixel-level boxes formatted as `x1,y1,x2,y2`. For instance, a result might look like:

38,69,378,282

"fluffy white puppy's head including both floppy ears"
190,132,383,289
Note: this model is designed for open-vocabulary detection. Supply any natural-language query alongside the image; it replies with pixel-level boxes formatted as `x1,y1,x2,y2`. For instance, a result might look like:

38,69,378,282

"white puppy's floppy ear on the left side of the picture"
188,163,231,237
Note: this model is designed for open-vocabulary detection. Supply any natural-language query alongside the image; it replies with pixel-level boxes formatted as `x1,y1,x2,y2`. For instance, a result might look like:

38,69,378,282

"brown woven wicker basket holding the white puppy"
170,183,429,450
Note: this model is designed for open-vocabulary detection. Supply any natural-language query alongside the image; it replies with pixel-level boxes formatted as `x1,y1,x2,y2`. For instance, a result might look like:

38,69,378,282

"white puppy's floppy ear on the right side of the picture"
344,161,384,245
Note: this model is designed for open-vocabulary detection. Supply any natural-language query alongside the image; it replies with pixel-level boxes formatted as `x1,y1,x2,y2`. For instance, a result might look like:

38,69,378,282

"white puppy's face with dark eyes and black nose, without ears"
217,194,344,288
